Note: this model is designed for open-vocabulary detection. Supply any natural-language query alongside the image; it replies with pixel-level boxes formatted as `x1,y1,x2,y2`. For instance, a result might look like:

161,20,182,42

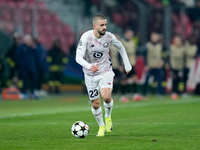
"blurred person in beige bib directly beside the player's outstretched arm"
121,29,142,100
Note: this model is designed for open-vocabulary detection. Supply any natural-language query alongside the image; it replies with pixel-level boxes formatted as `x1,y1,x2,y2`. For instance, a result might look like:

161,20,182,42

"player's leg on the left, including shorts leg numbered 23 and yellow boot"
85,75,105,136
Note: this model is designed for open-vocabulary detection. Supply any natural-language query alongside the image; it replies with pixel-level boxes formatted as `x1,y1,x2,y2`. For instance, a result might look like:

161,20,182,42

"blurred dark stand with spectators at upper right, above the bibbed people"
85,0,200,47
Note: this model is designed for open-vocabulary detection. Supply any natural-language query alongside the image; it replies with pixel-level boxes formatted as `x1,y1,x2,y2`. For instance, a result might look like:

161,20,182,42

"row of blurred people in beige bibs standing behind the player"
110,29,200,102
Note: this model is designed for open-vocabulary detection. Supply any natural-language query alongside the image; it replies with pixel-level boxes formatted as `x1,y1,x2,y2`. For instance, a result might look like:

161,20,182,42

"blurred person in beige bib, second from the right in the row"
169,35,185,99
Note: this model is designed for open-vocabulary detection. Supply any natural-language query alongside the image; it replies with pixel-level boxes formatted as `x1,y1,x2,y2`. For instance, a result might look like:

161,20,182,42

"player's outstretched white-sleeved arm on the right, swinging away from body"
112,35,132,73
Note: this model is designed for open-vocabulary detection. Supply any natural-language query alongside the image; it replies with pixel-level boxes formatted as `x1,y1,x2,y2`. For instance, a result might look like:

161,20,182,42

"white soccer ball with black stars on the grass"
71,121,89,138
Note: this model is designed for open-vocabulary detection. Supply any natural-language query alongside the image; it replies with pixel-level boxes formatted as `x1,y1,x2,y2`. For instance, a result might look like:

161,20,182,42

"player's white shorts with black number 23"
85,71,115,100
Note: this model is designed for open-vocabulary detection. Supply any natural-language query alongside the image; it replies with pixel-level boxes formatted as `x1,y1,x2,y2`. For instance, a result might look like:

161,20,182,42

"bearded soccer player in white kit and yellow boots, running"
76,15,132,137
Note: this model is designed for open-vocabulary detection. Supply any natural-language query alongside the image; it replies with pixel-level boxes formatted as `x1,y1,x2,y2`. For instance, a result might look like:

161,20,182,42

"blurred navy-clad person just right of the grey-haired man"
34,37,47,96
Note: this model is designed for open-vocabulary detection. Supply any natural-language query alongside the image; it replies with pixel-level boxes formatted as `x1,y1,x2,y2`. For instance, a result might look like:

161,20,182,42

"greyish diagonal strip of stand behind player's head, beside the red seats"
43,0,123,38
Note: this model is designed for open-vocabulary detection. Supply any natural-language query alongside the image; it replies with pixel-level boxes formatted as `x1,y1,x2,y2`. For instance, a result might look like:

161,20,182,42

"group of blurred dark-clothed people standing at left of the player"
0,33,68,99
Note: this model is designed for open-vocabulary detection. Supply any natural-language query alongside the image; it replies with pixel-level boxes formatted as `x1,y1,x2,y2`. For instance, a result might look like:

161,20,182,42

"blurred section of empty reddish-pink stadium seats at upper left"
0,0,75,54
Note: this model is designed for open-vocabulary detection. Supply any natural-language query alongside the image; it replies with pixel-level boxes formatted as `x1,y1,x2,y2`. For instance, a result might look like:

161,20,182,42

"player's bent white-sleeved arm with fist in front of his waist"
76,34,99,72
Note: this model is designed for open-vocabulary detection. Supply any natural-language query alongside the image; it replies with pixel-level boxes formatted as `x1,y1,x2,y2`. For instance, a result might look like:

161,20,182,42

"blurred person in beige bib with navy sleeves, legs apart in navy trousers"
143,32,164,99
